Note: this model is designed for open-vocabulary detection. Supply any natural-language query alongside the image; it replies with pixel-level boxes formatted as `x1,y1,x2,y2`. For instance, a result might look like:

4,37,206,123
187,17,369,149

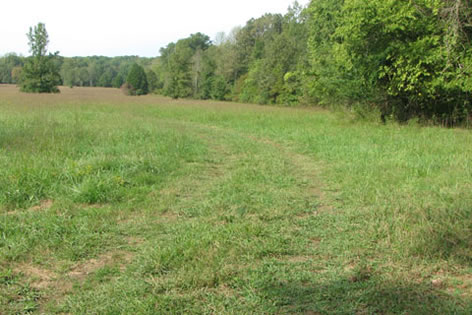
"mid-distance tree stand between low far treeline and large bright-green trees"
156,2,307,104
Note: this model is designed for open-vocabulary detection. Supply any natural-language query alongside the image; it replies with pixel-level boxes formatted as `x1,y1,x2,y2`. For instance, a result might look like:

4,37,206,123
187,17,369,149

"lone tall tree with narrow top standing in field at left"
20,23,61,93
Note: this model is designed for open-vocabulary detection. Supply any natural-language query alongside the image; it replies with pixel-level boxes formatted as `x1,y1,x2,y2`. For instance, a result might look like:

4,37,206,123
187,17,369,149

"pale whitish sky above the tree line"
0,0,309,57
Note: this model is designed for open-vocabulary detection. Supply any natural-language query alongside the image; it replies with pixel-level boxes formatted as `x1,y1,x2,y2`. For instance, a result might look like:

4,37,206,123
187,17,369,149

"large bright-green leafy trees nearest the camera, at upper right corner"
309,0,472,123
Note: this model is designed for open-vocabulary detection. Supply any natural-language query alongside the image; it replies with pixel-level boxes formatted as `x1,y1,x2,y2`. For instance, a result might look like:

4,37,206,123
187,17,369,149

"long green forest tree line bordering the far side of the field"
0,0,472,125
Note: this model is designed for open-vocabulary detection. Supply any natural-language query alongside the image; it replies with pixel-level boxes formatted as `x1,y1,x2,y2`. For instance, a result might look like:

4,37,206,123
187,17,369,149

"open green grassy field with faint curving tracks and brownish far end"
0,85,472,314
